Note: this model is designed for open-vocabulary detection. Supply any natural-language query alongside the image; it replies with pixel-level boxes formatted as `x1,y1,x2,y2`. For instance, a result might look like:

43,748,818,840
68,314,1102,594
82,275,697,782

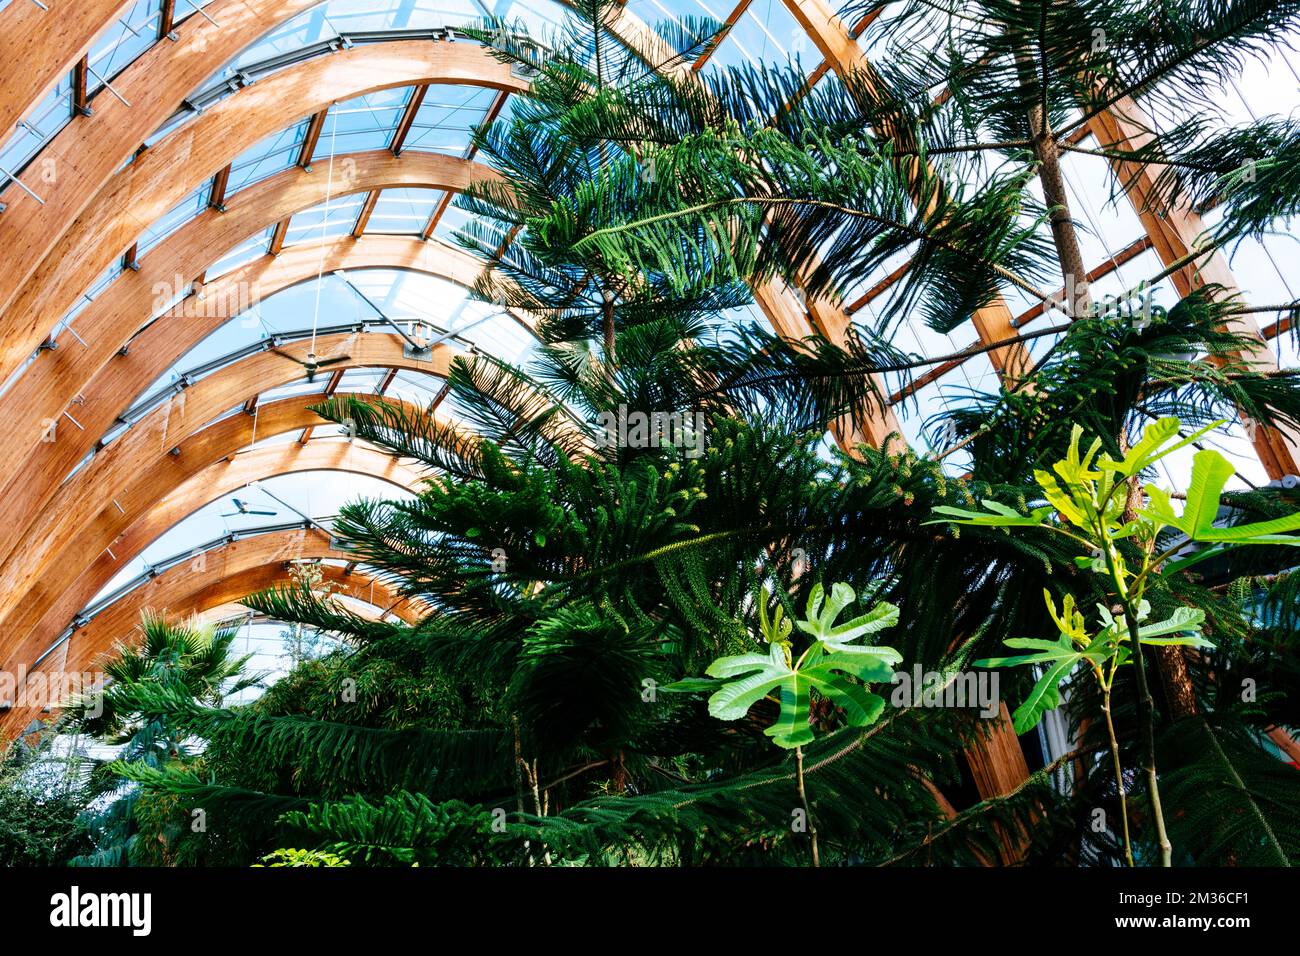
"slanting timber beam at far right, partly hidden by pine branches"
1088,99,1300,479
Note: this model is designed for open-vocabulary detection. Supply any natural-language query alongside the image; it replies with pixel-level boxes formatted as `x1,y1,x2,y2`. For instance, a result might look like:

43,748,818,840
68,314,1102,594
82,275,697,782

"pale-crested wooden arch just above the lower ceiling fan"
0,416,431,670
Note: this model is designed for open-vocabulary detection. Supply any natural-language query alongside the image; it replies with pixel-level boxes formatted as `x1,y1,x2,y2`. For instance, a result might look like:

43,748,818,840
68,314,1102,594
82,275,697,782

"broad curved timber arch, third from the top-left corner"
0,33,527,380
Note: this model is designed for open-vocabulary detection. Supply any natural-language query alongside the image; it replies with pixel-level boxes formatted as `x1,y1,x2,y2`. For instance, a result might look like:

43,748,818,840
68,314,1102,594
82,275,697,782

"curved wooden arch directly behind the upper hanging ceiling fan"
0,333,456,640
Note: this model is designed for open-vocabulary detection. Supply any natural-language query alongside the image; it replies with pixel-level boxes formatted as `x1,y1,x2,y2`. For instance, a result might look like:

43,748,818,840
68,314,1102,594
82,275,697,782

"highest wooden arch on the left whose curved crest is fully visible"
0,40,527,378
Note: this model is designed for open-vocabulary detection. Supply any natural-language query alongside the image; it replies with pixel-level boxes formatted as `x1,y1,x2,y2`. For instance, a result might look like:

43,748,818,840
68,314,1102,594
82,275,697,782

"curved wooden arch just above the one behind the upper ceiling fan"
0,235,517,572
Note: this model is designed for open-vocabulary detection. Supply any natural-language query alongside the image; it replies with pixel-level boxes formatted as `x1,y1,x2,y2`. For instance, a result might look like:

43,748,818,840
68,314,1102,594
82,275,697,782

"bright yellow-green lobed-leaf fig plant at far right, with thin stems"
935,418,1300,866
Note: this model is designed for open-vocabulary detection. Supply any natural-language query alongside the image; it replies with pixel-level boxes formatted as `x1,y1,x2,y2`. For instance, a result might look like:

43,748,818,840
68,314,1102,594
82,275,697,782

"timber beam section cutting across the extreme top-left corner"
0,0,133,149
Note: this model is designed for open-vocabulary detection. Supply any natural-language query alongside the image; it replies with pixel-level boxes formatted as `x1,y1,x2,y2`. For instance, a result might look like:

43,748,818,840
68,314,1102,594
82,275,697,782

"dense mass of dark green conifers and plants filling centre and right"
10,0,1300,866
